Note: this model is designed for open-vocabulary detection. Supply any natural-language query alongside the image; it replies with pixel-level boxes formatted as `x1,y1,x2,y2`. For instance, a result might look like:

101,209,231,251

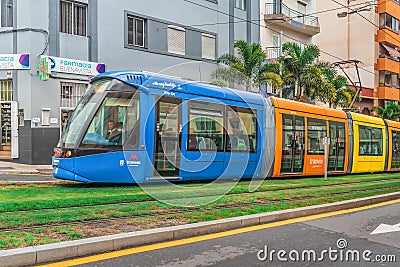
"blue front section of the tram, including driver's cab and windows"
53,71,275,183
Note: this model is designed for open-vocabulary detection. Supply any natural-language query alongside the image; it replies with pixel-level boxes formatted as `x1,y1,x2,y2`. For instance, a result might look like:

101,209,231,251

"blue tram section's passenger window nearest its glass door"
187,101,224,151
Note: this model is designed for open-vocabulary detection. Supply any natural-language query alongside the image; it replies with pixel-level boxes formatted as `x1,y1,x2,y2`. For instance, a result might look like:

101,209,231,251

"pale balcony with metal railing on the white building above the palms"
264,3,320,36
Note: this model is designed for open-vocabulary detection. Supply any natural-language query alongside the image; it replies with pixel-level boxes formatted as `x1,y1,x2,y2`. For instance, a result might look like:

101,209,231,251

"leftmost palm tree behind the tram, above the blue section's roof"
211,40,282,91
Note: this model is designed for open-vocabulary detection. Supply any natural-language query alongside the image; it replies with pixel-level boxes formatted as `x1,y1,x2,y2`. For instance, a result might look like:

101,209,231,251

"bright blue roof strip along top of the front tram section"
92,71,264,105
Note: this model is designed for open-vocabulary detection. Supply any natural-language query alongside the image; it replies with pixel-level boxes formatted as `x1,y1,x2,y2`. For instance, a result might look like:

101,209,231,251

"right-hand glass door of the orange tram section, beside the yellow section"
328,121,346,171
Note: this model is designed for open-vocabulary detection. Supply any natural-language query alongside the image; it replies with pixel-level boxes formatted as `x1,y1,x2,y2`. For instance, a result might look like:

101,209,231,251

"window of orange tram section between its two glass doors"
307,118,326,155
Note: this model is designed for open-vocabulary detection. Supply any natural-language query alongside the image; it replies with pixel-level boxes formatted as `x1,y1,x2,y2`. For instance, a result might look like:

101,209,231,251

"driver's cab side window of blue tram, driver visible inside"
81,92,139,148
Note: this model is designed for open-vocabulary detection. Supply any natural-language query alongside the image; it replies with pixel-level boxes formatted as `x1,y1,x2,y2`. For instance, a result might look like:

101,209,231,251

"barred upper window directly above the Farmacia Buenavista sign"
60,0,87,36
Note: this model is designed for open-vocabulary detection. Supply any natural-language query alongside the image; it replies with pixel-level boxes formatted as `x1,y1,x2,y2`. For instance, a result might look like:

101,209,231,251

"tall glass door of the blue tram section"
154,97,182,177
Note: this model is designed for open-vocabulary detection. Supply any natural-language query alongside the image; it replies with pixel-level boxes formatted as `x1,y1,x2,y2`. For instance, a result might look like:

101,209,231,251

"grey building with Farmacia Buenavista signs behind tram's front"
0,0,260,164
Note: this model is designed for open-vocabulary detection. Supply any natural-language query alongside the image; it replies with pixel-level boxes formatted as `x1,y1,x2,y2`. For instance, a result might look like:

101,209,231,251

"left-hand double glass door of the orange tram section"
281,114,305,173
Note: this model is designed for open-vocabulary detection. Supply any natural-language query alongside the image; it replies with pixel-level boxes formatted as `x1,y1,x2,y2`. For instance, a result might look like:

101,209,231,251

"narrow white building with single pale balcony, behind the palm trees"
260,0,320,60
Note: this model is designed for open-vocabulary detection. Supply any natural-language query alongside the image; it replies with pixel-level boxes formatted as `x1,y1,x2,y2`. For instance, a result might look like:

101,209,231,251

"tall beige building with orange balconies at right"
316,0,400,114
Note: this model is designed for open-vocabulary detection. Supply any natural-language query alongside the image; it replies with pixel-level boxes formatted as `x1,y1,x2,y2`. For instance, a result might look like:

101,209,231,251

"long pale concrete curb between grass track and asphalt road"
0,192,400,267
